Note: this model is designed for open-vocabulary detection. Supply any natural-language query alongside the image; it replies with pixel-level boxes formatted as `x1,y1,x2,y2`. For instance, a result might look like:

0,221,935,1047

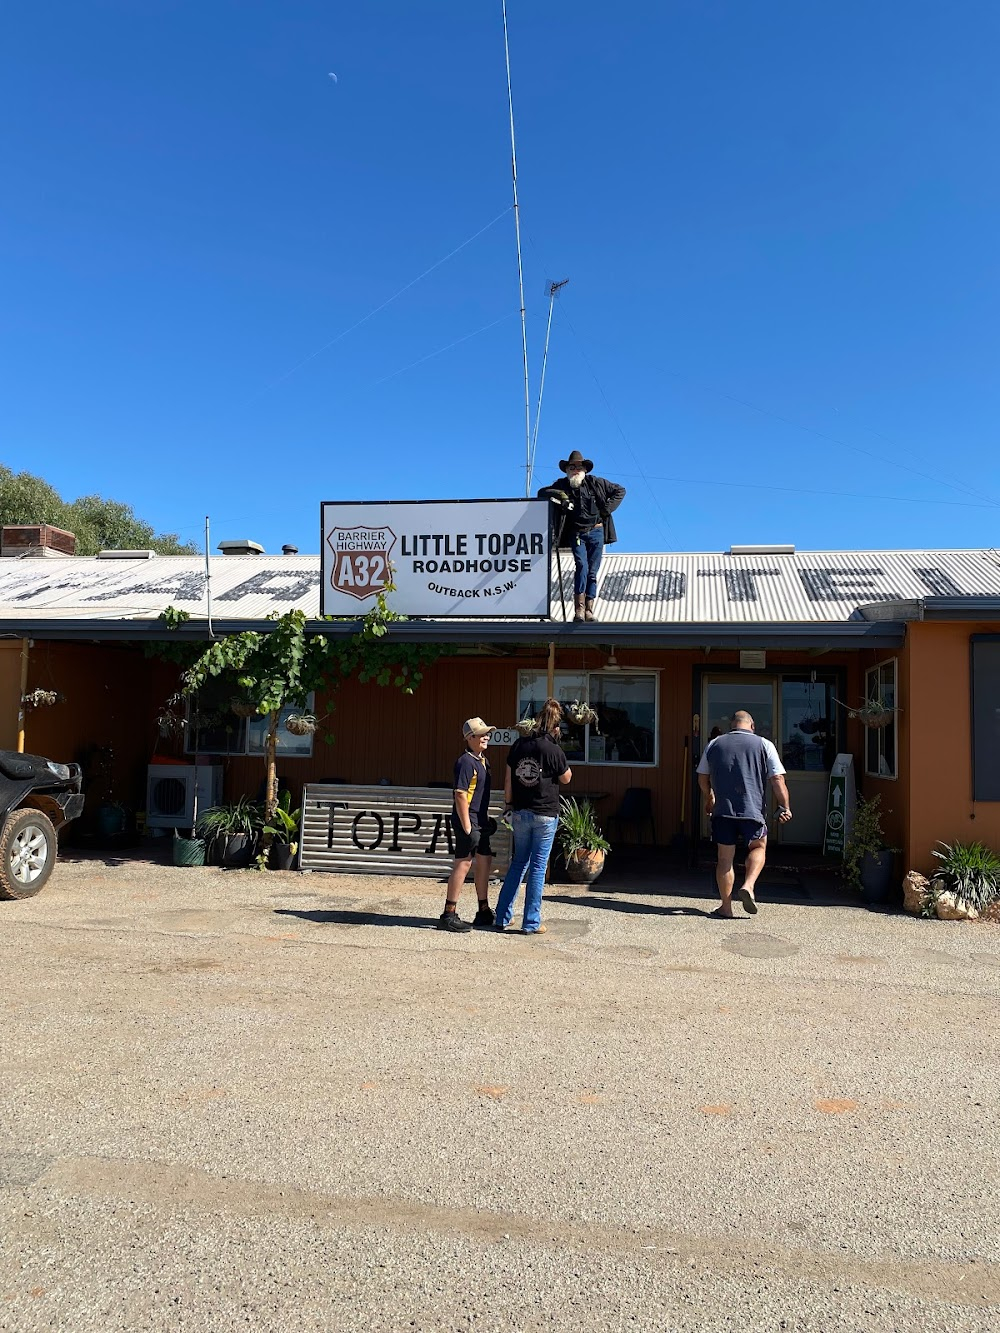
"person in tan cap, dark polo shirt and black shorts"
437,717,496,934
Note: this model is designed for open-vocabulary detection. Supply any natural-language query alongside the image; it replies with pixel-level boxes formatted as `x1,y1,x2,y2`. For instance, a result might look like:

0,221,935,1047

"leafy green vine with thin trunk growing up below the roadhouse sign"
152,584,448,825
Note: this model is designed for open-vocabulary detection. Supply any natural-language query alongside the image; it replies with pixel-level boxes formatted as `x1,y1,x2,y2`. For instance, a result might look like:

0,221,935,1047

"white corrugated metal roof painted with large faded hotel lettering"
0,551,1000,628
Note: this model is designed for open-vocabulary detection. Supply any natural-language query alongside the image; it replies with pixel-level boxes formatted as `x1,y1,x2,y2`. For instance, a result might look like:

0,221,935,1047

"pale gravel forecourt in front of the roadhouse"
0,858,1000,1333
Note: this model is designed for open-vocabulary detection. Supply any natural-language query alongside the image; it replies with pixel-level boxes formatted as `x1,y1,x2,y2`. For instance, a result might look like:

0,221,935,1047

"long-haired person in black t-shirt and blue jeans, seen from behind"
496,698,573,934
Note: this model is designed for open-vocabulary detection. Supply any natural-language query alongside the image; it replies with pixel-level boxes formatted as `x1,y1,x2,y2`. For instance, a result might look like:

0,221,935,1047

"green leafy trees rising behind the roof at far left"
0,465,197,556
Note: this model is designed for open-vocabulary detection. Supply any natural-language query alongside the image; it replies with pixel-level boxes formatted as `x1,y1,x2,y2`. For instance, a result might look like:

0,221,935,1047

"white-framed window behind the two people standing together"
517,670,657,765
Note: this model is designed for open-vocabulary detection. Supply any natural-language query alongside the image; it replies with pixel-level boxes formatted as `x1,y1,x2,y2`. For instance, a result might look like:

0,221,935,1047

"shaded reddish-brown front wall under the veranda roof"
0,641,890,842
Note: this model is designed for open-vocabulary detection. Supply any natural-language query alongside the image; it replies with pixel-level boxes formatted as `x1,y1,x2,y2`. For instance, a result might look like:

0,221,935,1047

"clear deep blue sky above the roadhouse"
0,0,1000,551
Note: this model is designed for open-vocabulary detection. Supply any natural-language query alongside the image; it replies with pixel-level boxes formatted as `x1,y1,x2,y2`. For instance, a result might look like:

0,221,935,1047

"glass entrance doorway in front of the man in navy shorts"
701,670,837,846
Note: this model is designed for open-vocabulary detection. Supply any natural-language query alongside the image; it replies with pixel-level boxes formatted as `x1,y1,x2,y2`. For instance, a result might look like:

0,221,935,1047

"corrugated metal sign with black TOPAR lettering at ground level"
299,782,511,878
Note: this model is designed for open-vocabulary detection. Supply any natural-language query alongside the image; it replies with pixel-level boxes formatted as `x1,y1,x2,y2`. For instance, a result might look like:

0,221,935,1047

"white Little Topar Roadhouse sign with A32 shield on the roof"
320,500,551,620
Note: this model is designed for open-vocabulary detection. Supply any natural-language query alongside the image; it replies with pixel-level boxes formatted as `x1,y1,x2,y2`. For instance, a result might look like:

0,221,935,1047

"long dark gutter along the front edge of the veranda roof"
0,618,906,649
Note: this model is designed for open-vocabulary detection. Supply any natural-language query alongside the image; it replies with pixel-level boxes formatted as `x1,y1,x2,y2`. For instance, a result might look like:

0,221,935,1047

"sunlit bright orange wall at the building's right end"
901,621,1000,873
